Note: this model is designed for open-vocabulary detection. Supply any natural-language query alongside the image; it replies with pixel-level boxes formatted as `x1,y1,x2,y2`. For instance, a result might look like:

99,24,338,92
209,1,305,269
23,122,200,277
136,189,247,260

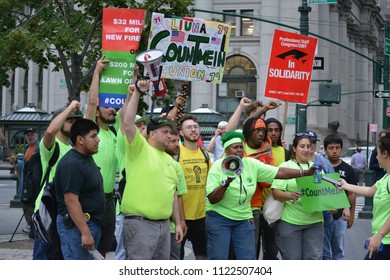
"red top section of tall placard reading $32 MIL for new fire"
102,8,146,53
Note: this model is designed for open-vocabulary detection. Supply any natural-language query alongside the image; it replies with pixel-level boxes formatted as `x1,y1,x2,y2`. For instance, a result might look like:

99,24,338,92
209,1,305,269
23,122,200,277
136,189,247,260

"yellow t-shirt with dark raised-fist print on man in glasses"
179,145,211,220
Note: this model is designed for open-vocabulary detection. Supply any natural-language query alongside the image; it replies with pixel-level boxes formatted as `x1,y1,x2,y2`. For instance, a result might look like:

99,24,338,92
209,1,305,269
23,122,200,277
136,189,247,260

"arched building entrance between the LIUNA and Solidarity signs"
217,55,257,118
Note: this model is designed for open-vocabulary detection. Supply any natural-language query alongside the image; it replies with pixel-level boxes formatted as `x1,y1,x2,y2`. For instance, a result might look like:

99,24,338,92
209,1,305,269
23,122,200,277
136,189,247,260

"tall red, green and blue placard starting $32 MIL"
99,8,146,108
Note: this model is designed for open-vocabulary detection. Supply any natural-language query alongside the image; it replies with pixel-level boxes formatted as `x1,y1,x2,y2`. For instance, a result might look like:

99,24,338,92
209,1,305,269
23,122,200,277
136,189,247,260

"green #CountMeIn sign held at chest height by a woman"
295,173,350,212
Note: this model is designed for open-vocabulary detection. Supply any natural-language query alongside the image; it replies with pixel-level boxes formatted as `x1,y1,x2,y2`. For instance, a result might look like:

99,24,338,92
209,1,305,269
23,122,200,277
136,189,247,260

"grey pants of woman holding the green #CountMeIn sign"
276,221,324,260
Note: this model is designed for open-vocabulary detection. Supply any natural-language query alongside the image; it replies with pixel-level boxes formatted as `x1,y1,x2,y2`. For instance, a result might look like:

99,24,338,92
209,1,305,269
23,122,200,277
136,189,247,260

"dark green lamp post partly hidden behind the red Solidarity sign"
295,0,311,133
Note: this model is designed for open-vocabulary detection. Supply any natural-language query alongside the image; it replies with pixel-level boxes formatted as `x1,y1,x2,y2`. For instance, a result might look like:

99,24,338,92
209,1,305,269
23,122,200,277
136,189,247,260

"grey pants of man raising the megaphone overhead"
124,219,171,260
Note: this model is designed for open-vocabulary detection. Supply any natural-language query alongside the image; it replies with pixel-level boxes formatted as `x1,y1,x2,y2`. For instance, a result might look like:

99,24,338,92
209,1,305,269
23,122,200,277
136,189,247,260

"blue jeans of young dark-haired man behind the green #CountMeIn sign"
323,215,347,260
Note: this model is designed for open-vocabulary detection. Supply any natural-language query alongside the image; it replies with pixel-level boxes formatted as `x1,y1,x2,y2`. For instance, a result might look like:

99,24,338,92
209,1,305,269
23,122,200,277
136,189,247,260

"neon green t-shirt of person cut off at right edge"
372,174,390,245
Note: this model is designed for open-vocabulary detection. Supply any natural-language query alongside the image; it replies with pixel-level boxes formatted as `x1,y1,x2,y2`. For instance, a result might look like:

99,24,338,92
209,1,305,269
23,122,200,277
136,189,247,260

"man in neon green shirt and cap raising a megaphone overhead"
122,81,180,260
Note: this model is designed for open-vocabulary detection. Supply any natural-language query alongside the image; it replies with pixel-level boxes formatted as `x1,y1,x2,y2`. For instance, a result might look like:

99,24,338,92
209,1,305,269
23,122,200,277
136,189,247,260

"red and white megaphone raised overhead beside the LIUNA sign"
135,49,167,98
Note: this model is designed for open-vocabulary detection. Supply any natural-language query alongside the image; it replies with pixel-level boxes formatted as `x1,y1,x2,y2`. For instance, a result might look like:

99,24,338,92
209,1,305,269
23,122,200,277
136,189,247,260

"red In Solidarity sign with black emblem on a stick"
264,30,317,104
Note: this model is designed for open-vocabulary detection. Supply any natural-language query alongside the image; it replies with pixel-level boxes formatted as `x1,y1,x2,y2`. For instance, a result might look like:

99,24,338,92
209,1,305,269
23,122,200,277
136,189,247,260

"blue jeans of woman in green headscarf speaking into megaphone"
206,211,256,260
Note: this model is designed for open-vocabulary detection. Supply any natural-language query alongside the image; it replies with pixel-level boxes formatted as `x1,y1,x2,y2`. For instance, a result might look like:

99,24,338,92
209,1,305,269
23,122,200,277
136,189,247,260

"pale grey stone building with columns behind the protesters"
0,0,390,146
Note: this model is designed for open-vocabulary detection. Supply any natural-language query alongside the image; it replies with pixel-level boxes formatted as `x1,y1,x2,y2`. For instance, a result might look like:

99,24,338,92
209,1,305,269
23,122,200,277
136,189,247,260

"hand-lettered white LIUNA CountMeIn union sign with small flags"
148,13,231,83
